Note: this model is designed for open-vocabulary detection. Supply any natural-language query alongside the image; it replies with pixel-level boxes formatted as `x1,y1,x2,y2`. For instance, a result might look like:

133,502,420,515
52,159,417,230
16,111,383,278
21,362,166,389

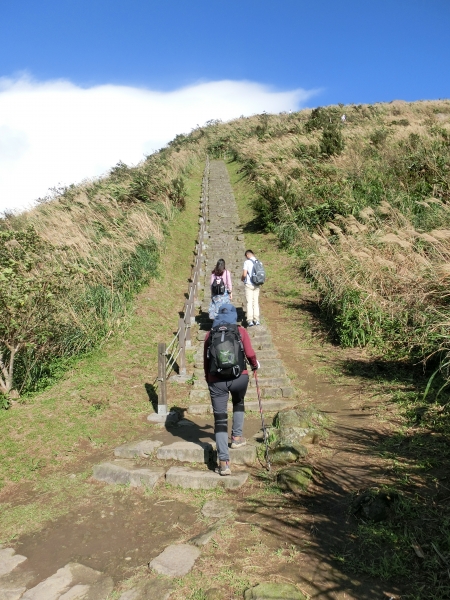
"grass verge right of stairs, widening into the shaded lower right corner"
228,157,450,600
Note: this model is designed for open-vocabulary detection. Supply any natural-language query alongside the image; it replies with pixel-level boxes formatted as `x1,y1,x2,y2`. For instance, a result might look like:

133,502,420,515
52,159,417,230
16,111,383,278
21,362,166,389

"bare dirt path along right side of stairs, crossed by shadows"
263,296,400,600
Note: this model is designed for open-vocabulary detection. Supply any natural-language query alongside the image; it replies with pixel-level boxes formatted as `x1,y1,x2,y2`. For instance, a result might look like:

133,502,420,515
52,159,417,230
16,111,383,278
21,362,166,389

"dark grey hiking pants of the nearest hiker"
208,374,248,460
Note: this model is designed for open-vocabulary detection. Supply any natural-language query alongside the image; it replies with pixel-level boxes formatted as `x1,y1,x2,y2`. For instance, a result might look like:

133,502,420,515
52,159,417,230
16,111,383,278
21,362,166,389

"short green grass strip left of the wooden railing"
0,158,203,539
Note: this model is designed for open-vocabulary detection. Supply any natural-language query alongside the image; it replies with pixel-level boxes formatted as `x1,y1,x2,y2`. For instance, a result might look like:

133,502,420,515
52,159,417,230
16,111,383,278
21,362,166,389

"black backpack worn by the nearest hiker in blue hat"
207,323,245,379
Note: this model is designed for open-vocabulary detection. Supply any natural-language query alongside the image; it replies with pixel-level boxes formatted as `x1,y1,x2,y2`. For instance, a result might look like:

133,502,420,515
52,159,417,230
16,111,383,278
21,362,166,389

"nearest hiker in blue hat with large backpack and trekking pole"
203,304,259,475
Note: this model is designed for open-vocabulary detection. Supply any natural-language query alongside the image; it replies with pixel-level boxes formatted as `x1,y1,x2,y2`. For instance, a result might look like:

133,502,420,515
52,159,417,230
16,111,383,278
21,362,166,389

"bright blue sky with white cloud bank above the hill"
0,0,450,210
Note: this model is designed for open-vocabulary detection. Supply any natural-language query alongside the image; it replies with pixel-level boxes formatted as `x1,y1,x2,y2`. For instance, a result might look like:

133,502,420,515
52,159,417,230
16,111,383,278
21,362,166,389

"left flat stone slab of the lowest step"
93,459,164,488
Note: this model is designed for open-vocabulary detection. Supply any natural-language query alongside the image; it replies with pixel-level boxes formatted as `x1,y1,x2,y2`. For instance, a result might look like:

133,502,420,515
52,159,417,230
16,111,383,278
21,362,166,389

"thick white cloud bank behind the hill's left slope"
0,76,315,212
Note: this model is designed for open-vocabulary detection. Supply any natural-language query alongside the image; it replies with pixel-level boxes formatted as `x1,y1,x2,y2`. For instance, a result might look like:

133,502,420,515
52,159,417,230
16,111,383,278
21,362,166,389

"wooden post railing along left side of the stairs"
158,158,209,415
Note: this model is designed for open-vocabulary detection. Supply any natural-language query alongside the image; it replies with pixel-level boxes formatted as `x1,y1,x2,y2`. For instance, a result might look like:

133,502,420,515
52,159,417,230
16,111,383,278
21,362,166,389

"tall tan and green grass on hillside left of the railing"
0,144,198,406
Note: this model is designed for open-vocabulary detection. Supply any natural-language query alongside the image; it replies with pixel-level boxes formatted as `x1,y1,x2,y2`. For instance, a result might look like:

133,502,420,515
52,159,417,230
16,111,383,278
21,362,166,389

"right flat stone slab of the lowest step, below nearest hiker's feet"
166,467,248,490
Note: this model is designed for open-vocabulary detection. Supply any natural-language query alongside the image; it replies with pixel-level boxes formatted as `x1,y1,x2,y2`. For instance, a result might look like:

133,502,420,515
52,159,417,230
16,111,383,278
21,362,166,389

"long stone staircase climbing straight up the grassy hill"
88,161,297,489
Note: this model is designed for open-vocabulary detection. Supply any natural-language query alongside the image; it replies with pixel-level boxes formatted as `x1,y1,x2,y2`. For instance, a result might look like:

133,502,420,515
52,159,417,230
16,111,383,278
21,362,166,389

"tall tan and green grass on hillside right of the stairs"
200,101,450,359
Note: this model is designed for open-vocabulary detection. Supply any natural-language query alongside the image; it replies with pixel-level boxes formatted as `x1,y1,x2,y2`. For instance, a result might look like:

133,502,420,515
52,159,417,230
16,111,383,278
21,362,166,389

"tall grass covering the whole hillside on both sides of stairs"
0,100,450,404
